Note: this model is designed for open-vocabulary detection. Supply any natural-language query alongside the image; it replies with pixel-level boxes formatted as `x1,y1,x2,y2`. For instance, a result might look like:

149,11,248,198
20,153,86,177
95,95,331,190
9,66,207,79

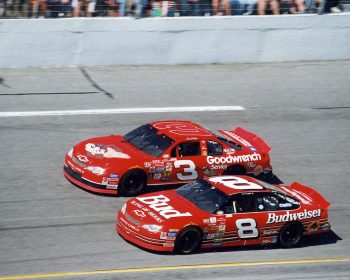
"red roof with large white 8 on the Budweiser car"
204,175,274,196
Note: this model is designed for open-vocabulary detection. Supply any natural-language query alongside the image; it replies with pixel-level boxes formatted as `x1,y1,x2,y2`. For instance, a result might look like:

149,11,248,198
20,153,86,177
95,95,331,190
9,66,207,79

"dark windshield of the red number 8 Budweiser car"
176,180,228,214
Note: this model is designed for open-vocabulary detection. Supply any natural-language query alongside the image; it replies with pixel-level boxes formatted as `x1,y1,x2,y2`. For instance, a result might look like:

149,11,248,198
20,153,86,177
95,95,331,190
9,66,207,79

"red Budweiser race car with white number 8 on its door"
116,175,330,254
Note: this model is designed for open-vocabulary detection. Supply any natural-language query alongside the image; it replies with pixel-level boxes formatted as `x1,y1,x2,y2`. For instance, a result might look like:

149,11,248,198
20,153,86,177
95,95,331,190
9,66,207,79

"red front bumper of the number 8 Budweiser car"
116,217,174,252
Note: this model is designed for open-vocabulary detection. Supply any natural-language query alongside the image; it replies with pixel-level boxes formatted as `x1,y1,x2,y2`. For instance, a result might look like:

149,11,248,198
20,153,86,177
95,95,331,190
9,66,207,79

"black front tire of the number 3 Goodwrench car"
119,169,147,196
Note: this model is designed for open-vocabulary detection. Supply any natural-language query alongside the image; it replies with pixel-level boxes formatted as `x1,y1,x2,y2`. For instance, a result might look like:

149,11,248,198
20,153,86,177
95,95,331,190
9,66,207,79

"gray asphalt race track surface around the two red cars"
0,61,350,280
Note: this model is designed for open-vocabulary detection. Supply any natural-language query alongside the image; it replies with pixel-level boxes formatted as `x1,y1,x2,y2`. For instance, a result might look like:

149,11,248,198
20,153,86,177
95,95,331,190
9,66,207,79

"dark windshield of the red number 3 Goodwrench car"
124,124,174,157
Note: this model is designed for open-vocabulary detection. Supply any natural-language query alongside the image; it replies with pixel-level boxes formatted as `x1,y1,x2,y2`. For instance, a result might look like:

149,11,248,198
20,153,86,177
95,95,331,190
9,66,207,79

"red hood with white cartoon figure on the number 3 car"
72,135,147,166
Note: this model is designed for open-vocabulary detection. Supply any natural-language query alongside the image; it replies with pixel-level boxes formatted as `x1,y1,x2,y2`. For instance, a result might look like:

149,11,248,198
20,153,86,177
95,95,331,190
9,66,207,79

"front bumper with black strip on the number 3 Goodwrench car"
63,165,118,194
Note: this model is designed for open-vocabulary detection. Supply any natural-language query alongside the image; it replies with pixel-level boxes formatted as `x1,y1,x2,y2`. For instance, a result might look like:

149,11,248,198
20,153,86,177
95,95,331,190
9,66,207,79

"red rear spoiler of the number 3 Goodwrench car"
219,127,271,153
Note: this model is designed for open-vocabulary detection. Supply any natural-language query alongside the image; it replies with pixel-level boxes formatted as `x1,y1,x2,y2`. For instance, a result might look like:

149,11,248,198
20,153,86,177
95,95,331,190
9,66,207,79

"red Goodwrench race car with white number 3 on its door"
64,121,272,196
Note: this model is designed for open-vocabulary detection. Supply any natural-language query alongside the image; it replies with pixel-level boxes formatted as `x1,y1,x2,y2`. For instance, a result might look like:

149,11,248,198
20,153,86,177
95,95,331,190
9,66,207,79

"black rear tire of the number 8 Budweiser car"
278,223,303,248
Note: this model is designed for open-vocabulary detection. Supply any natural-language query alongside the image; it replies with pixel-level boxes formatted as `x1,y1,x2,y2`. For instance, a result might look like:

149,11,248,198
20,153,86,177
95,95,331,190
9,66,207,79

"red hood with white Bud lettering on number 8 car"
125,190,204,227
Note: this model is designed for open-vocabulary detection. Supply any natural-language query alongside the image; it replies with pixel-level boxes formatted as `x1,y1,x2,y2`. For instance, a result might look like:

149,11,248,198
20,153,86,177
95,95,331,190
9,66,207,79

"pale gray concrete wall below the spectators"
0,14,350,67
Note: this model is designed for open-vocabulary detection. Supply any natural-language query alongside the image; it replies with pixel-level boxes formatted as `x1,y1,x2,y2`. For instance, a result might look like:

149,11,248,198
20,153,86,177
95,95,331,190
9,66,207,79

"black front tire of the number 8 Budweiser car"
175,226,202,255
